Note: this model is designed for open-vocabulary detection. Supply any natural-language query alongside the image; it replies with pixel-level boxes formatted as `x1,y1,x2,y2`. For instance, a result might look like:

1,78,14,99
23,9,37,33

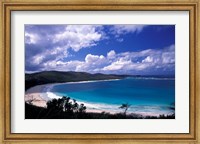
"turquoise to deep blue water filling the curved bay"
50,78,175,113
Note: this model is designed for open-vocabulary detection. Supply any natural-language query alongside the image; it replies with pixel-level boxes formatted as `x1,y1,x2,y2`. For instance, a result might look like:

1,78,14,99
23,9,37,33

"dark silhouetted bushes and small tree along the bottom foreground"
25,97,175,119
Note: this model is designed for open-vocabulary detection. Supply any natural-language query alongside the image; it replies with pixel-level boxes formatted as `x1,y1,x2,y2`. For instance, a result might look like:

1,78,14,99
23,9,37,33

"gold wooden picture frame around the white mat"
0,0,200,144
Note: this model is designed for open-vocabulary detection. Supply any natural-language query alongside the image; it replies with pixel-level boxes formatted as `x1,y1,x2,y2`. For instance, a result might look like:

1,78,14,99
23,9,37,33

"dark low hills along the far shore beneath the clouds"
25,71,127,90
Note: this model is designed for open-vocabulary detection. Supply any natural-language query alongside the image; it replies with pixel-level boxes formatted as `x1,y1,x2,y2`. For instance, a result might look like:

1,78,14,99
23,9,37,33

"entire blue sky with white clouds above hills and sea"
25,25,175,75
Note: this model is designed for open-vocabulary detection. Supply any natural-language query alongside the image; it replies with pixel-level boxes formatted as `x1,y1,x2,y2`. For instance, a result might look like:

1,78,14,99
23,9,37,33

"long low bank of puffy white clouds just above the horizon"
41,45,175,74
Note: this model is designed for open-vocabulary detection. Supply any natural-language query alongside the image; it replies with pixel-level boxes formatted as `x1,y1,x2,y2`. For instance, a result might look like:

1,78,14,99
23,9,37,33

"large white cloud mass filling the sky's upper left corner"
25,25,105,71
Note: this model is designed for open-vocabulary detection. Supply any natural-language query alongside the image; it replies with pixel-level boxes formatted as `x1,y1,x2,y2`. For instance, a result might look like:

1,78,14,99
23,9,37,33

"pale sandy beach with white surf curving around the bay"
25,79,175,116
